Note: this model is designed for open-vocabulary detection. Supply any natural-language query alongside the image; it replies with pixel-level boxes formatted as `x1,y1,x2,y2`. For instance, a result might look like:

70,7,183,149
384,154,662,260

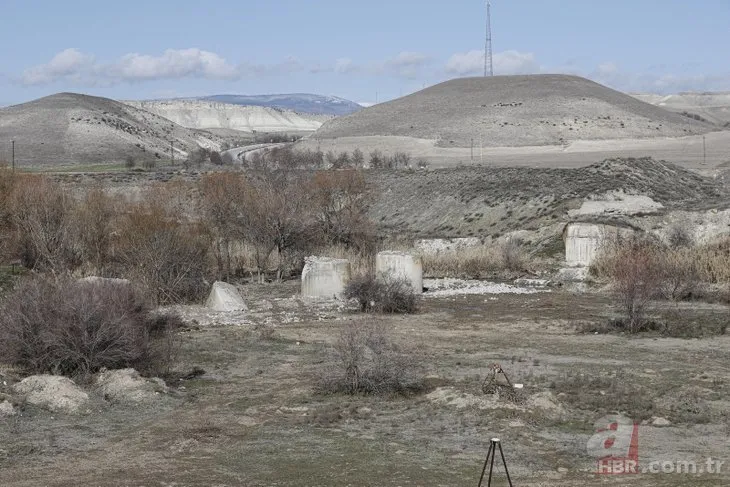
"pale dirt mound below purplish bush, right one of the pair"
96,369,167,403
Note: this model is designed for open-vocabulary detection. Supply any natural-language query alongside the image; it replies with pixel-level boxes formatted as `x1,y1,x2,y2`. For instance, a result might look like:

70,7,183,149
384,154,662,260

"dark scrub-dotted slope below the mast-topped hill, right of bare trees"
368,159,730,238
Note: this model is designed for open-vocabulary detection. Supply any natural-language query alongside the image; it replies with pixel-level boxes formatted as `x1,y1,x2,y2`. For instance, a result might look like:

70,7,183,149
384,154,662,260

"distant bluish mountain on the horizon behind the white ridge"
198,93,362,117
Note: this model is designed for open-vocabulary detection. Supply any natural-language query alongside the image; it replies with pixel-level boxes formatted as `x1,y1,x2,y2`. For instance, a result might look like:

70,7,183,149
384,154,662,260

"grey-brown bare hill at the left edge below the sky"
0,93,222,166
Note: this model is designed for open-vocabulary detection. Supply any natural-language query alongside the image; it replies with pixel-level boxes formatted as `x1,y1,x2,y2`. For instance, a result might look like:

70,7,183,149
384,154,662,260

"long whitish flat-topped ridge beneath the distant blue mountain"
125,100,332,132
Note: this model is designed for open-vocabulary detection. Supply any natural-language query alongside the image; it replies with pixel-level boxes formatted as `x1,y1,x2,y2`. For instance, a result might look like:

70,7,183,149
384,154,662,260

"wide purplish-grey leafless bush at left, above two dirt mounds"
0,278,179,376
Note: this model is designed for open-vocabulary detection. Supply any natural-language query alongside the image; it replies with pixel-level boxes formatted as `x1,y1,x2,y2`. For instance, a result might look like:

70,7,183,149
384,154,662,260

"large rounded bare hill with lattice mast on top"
316,75,714,147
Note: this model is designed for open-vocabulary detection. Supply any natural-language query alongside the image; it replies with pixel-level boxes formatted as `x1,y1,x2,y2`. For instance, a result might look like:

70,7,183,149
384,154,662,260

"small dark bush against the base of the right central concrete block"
343,274,418,313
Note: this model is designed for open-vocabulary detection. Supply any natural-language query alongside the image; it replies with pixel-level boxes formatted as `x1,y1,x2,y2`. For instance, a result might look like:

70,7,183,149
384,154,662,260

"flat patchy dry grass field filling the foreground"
0,281,730,487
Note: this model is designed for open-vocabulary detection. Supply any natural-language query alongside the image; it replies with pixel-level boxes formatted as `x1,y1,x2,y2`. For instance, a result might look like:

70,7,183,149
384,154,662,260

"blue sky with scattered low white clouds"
0,0,730,105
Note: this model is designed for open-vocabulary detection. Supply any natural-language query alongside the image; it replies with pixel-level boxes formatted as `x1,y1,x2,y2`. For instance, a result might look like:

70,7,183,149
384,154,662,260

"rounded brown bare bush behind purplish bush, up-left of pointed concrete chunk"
116,202,210,304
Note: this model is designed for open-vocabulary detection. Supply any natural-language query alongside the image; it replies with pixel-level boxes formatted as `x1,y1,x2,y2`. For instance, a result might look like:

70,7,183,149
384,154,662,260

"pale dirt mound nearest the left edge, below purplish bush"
13,375,89,414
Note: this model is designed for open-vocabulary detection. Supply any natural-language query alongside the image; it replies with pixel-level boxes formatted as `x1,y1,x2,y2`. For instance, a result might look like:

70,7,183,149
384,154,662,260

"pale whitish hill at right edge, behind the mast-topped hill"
631,92,730,127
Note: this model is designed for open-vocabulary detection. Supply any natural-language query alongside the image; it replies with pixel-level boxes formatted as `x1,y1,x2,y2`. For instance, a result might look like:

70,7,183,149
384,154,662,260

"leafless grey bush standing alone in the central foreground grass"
318,321,424,394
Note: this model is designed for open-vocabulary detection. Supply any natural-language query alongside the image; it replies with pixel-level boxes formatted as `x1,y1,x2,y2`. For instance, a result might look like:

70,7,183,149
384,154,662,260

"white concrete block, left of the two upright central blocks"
302,256,350,298
